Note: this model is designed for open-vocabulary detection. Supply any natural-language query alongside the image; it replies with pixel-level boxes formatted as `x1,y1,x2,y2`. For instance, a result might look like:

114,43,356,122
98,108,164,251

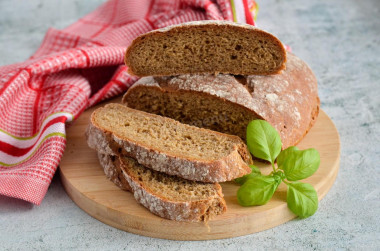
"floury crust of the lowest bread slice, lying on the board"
98,153,227,222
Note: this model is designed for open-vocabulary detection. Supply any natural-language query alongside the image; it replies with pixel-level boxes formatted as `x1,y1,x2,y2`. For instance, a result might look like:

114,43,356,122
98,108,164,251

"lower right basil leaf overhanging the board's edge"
287,182,318,218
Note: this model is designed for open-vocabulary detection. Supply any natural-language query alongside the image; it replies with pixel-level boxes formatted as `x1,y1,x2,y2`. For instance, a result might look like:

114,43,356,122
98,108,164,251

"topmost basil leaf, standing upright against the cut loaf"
247,119,281,163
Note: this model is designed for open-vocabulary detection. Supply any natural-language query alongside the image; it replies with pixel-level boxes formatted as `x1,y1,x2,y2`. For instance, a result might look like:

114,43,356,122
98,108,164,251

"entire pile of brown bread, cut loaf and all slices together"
87,21,319,221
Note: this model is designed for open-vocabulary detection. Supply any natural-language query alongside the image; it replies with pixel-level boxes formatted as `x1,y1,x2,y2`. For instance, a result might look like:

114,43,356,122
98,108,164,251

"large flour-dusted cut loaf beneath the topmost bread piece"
122,54,320,148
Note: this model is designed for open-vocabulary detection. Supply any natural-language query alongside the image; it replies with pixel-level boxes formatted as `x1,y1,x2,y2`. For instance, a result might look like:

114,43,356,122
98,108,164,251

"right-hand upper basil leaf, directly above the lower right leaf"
279,148,320,181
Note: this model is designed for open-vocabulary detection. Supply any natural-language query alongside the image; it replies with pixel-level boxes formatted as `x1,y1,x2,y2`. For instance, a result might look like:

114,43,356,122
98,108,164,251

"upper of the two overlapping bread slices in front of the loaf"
87,104,252,182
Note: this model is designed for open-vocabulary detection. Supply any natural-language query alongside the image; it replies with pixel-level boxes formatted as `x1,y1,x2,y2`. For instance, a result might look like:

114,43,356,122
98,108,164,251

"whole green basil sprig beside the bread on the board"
235,120,320,218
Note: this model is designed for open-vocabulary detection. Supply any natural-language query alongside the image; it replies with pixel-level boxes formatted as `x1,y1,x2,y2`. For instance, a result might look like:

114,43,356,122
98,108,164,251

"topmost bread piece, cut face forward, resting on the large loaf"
125,21,286,77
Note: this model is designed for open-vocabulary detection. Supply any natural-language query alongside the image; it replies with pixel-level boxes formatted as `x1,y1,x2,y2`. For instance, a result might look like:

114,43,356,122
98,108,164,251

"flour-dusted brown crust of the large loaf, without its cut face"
122,53,320,148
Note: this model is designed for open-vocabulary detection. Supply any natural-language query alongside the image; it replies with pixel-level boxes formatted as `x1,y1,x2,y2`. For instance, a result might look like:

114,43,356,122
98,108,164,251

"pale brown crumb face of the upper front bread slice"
93,104,242,160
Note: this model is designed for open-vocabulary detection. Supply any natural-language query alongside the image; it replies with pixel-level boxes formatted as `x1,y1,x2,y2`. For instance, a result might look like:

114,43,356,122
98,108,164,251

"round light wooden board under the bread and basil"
60,98,340,240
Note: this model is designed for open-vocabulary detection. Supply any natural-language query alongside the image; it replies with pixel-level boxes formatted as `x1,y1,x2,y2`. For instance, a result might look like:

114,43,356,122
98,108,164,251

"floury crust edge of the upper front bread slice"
87,108,252,183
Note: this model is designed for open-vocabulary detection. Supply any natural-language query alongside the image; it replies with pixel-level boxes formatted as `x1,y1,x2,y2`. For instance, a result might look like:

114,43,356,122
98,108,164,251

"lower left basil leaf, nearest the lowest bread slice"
237,175,278,207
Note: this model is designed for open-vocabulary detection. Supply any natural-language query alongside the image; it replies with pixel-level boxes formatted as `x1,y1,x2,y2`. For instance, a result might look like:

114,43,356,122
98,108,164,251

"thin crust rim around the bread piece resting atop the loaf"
124,20,287,77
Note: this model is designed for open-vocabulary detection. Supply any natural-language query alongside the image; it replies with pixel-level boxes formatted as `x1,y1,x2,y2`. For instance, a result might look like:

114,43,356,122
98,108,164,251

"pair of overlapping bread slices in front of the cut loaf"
87,104,252,221
